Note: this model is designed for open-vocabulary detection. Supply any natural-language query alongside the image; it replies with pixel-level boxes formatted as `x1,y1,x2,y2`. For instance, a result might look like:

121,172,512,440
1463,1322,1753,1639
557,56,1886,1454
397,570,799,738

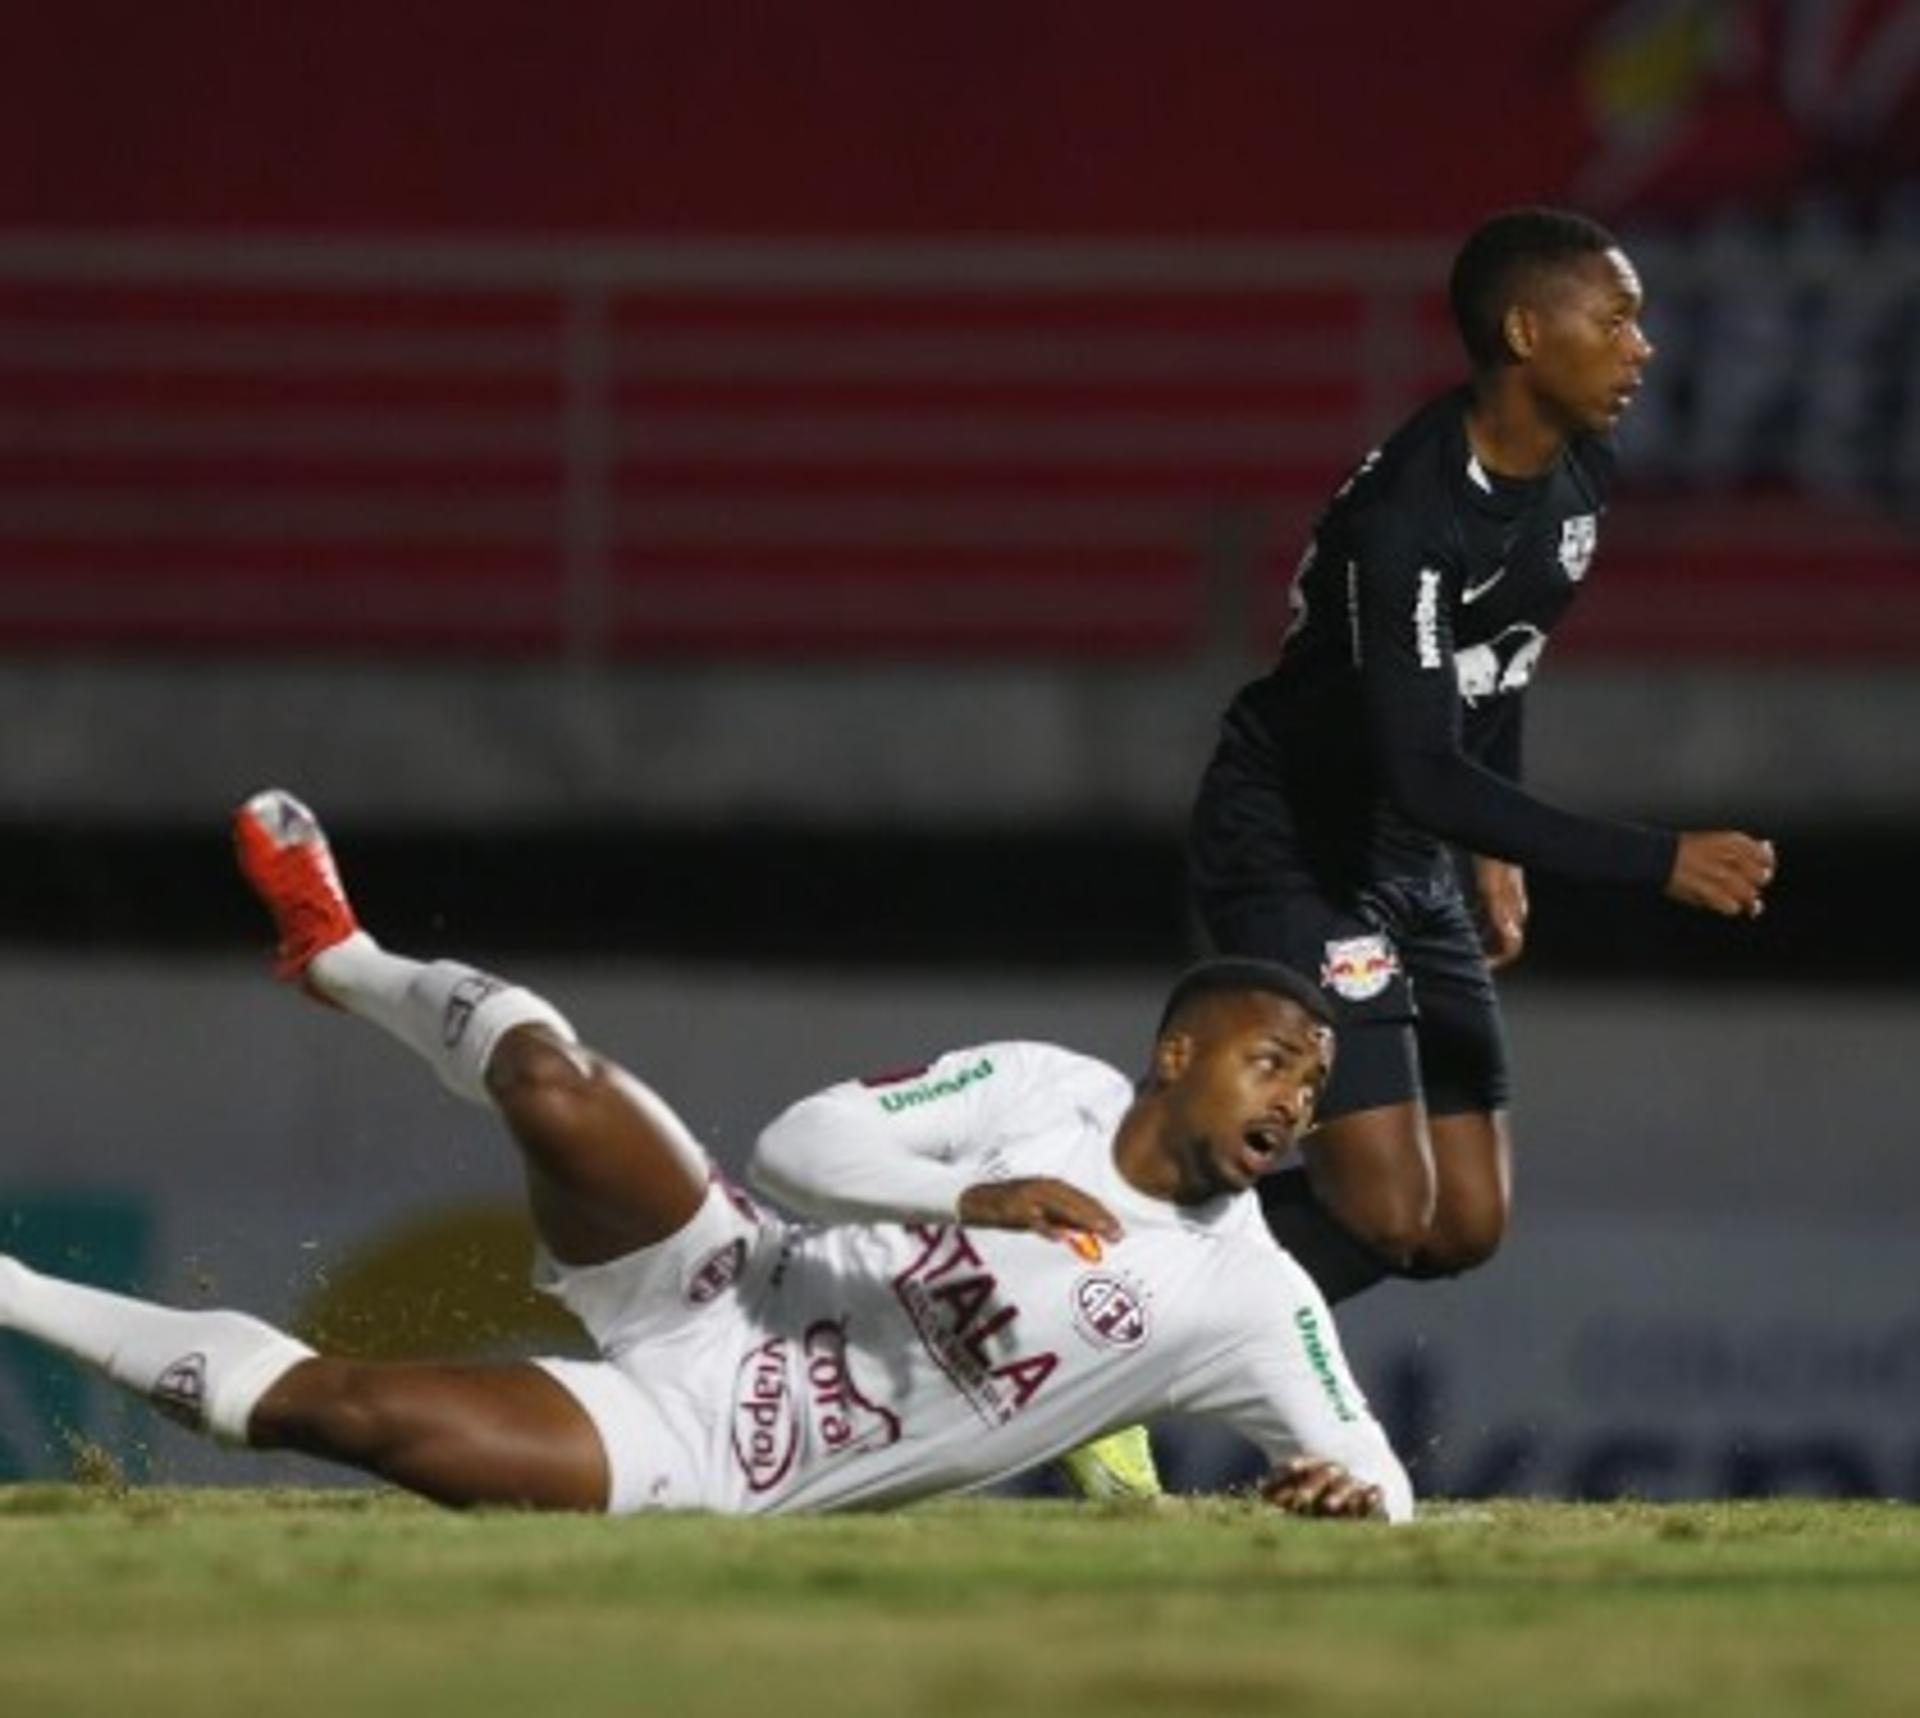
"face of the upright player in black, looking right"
1530,250,1653,434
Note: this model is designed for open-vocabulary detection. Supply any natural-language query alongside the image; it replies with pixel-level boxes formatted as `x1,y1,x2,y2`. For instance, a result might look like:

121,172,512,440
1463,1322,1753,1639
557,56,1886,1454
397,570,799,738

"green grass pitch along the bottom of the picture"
0,1486,1920,1718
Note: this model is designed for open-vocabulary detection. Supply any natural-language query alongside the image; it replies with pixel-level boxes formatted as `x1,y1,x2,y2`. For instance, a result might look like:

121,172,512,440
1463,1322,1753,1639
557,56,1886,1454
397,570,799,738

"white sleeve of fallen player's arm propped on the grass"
1177,1248,1413,1522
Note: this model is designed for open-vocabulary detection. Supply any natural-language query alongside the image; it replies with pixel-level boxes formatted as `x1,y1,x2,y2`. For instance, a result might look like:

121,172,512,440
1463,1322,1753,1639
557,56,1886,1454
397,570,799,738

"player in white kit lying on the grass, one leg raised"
0,789,1413,1520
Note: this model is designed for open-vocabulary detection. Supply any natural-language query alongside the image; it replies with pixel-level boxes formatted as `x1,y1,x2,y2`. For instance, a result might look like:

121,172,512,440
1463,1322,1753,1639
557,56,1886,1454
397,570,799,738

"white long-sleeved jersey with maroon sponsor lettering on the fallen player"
710,1042,1411,1520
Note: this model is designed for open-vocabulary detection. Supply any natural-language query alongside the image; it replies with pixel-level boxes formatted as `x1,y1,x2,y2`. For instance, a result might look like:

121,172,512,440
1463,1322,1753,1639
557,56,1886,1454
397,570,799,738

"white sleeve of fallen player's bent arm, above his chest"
747,1042,1052,1223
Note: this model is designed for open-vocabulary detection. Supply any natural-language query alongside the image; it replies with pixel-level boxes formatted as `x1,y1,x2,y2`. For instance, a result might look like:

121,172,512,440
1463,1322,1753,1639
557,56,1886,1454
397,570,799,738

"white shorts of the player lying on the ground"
534,1177,785,1515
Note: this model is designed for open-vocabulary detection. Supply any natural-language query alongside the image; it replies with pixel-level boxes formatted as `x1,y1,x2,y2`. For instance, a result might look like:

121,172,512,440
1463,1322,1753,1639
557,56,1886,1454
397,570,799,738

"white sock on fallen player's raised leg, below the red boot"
307,931,578,1104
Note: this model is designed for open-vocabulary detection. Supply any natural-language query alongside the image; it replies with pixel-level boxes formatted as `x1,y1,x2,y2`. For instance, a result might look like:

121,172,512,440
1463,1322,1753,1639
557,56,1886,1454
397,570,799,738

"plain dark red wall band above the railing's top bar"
11,0,1920,238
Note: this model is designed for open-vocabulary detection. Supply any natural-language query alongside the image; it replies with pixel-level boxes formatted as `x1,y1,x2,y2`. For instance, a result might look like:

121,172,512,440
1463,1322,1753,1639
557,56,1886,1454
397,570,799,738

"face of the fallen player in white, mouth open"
1181,994,1332,1192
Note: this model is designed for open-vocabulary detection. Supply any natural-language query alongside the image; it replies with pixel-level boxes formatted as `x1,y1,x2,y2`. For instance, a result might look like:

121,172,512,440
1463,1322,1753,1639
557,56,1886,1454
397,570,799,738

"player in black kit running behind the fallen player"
1190,209,1774,1300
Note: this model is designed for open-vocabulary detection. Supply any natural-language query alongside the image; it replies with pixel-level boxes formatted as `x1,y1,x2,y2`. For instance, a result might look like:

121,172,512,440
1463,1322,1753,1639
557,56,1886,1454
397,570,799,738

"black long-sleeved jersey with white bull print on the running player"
1225,388,1674,885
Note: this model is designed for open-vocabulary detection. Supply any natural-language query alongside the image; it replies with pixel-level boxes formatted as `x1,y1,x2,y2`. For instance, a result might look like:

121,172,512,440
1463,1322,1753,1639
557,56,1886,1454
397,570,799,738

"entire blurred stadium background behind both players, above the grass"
0,0,1920,1497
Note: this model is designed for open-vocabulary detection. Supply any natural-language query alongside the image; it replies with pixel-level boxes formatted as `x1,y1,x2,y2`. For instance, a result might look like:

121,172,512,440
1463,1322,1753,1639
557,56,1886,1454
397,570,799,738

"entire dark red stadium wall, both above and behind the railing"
0,0,1920,658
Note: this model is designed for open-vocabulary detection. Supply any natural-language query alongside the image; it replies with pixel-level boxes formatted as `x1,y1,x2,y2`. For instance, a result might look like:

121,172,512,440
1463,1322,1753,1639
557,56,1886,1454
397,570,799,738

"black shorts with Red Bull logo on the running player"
1188,749,1511,1121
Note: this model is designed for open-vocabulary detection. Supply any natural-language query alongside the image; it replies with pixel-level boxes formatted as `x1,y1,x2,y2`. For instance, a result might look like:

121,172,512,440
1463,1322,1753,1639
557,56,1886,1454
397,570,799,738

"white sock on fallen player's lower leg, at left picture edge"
0,1255,313,1444
